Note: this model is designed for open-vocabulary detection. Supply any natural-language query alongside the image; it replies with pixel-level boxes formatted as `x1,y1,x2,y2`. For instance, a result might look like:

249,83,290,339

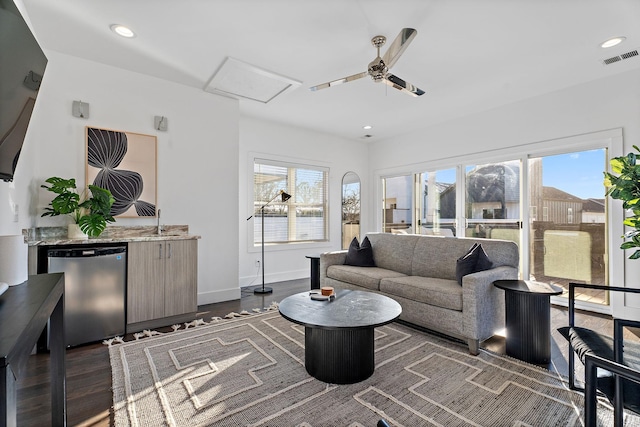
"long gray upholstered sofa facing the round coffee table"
320,233,519,355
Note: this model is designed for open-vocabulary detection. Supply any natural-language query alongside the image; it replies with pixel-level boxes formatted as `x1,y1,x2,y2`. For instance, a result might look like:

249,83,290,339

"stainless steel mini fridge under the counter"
47,245,127,346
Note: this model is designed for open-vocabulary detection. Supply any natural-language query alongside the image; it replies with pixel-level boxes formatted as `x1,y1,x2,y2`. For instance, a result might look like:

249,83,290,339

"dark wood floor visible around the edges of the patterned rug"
18,279,612,426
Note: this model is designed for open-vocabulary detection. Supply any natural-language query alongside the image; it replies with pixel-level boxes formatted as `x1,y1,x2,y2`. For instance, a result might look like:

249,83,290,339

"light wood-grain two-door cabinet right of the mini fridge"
127,239,198,325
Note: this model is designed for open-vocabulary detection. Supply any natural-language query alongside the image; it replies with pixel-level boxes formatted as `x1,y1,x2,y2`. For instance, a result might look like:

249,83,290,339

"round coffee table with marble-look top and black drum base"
279,290,402,384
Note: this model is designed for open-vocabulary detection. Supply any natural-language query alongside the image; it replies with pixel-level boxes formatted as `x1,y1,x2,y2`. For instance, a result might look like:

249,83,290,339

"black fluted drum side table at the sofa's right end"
493,280,562,365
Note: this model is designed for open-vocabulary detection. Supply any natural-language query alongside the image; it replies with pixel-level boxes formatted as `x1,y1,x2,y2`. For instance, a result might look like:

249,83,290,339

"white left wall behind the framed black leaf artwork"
0,52,240,304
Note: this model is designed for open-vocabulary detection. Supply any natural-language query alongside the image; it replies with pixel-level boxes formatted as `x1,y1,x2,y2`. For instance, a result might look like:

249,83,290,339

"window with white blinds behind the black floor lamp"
253,159,329,246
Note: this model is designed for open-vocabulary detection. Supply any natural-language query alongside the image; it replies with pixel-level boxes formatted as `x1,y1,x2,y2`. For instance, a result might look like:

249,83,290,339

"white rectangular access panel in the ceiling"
204,57,302,104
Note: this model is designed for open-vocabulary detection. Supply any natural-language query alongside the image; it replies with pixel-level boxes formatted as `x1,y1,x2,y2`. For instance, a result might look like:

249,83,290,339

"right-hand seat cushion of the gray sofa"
380,276,462,311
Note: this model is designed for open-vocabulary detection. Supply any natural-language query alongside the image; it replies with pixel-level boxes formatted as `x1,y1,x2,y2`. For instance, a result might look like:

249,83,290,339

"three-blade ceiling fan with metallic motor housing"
309,28,424,96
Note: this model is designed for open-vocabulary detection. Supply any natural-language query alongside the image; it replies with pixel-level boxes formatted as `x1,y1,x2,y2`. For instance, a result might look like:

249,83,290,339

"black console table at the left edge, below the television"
0,273,67,427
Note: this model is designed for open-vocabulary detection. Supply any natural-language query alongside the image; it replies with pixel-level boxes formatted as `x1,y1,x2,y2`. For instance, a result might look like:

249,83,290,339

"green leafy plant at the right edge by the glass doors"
604,145,640,259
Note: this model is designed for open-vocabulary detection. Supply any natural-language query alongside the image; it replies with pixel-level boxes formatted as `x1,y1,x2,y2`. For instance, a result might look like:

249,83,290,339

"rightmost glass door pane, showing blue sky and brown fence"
528,148,609,304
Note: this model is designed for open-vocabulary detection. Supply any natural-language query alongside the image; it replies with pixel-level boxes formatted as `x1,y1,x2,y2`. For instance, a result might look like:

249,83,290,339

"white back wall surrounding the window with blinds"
238,117,370,286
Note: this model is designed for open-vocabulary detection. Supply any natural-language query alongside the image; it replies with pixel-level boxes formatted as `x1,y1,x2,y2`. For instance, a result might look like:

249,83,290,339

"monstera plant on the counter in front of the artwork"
41,176,115,237
